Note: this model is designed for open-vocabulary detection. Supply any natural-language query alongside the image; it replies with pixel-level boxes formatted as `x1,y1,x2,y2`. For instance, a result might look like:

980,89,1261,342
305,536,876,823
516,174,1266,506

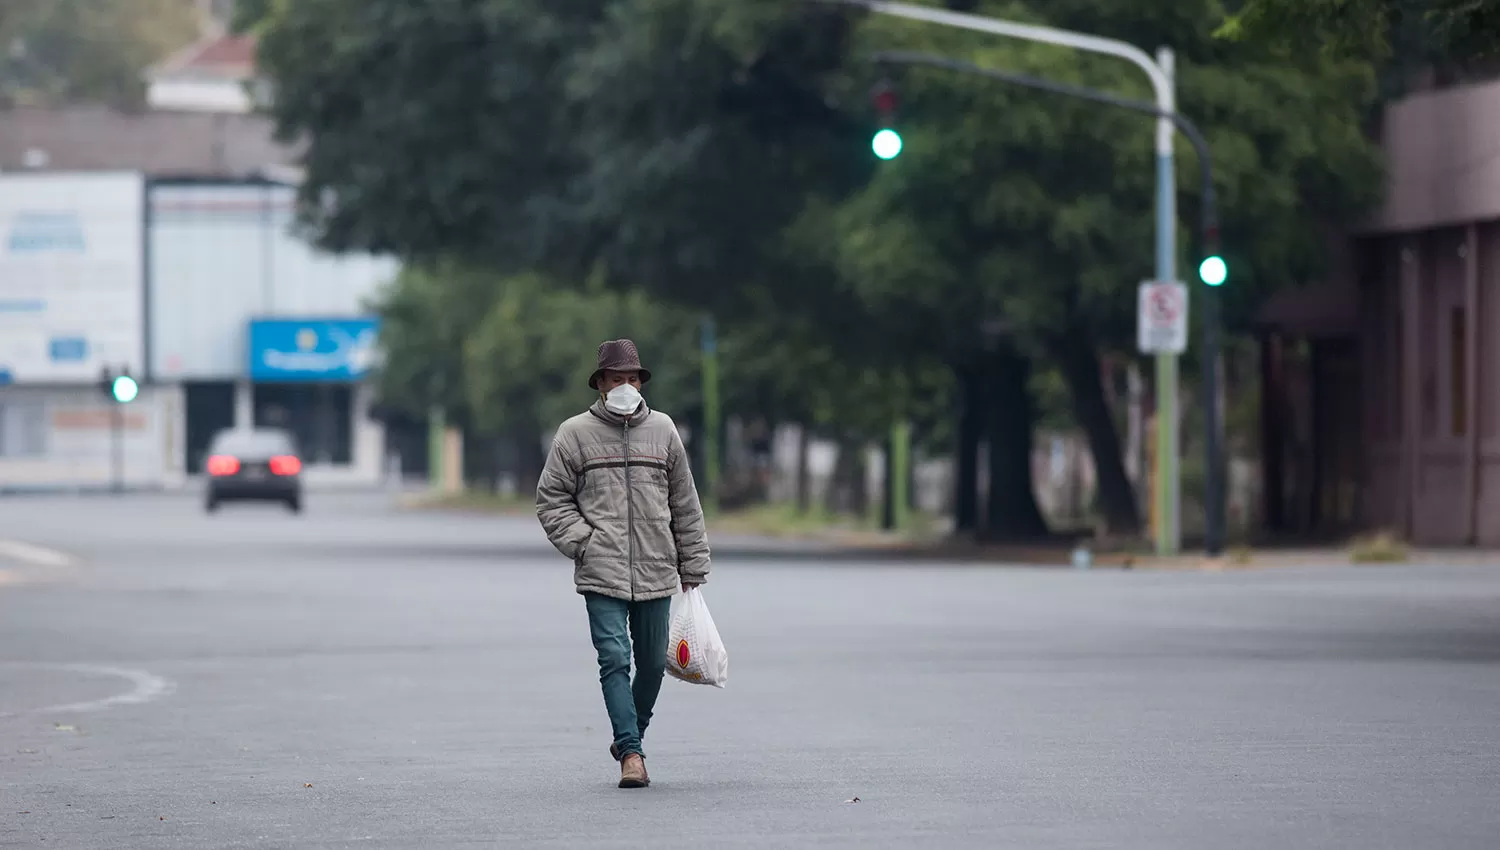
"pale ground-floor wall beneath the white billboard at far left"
0,385,171,492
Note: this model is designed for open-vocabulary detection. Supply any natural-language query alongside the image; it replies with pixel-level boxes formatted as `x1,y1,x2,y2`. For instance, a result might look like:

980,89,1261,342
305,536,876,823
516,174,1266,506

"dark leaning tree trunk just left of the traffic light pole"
1058,339,1140,537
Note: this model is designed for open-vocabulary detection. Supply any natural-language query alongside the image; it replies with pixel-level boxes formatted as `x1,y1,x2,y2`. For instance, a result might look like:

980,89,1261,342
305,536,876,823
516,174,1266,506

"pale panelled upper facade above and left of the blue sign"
147,184,399,381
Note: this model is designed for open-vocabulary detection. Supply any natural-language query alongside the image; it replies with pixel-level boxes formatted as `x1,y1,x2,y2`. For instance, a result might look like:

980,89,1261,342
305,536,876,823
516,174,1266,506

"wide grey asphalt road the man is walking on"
0,495,1500,850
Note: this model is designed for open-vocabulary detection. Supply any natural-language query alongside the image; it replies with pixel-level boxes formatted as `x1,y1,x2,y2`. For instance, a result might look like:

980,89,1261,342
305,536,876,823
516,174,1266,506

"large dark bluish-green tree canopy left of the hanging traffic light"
251,0,966,515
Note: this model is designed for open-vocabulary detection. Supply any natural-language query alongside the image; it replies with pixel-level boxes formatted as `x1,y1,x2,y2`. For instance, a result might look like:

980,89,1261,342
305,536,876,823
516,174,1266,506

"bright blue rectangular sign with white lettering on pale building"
249,318,380,381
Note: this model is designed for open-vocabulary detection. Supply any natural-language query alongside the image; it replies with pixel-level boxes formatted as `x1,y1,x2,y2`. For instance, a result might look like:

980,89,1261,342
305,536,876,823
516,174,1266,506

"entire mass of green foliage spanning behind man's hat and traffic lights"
258,0,1380,533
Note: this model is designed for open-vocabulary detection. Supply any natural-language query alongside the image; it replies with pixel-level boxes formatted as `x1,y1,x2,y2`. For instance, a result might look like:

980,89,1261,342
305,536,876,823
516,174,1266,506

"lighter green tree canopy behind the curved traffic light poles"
833,1,1380,358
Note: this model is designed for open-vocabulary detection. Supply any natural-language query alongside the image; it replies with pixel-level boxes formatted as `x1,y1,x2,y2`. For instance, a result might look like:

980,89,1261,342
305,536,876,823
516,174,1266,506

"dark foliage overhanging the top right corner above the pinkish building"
1220,0,1500,60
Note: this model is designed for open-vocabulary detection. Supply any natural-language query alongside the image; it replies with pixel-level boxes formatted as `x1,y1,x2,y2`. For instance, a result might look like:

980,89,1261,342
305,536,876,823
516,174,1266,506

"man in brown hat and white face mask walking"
537,339,710,789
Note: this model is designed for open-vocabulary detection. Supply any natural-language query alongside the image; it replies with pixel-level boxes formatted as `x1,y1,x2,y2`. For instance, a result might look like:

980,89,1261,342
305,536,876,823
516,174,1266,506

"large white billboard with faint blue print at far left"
0,174,146,384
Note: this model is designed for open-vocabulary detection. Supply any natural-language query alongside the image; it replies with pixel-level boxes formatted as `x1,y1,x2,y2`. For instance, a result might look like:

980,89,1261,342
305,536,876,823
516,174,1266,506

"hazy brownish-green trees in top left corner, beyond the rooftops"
0,0,200,106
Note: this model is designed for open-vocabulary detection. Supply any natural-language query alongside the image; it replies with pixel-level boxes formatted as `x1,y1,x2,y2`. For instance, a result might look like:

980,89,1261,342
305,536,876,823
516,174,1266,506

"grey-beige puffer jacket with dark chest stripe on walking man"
537,400,710,600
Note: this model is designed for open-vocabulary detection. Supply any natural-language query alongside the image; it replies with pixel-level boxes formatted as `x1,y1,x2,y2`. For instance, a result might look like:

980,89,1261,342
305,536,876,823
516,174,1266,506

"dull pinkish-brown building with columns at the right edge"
1263,81,1500,546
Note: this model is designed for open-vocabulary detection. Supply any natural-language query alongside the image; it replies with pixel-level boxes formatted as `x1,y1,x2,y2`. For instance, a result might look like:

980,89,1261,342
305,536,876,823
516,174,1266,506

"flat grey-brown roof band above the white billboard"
0,106,299,177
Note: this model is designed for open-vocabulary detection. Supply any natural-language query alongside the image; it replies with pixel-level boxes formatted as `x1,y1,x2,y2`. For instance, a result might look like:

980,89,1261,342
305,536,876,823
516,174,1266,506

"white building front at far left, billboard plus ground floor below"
0,172,167,490
